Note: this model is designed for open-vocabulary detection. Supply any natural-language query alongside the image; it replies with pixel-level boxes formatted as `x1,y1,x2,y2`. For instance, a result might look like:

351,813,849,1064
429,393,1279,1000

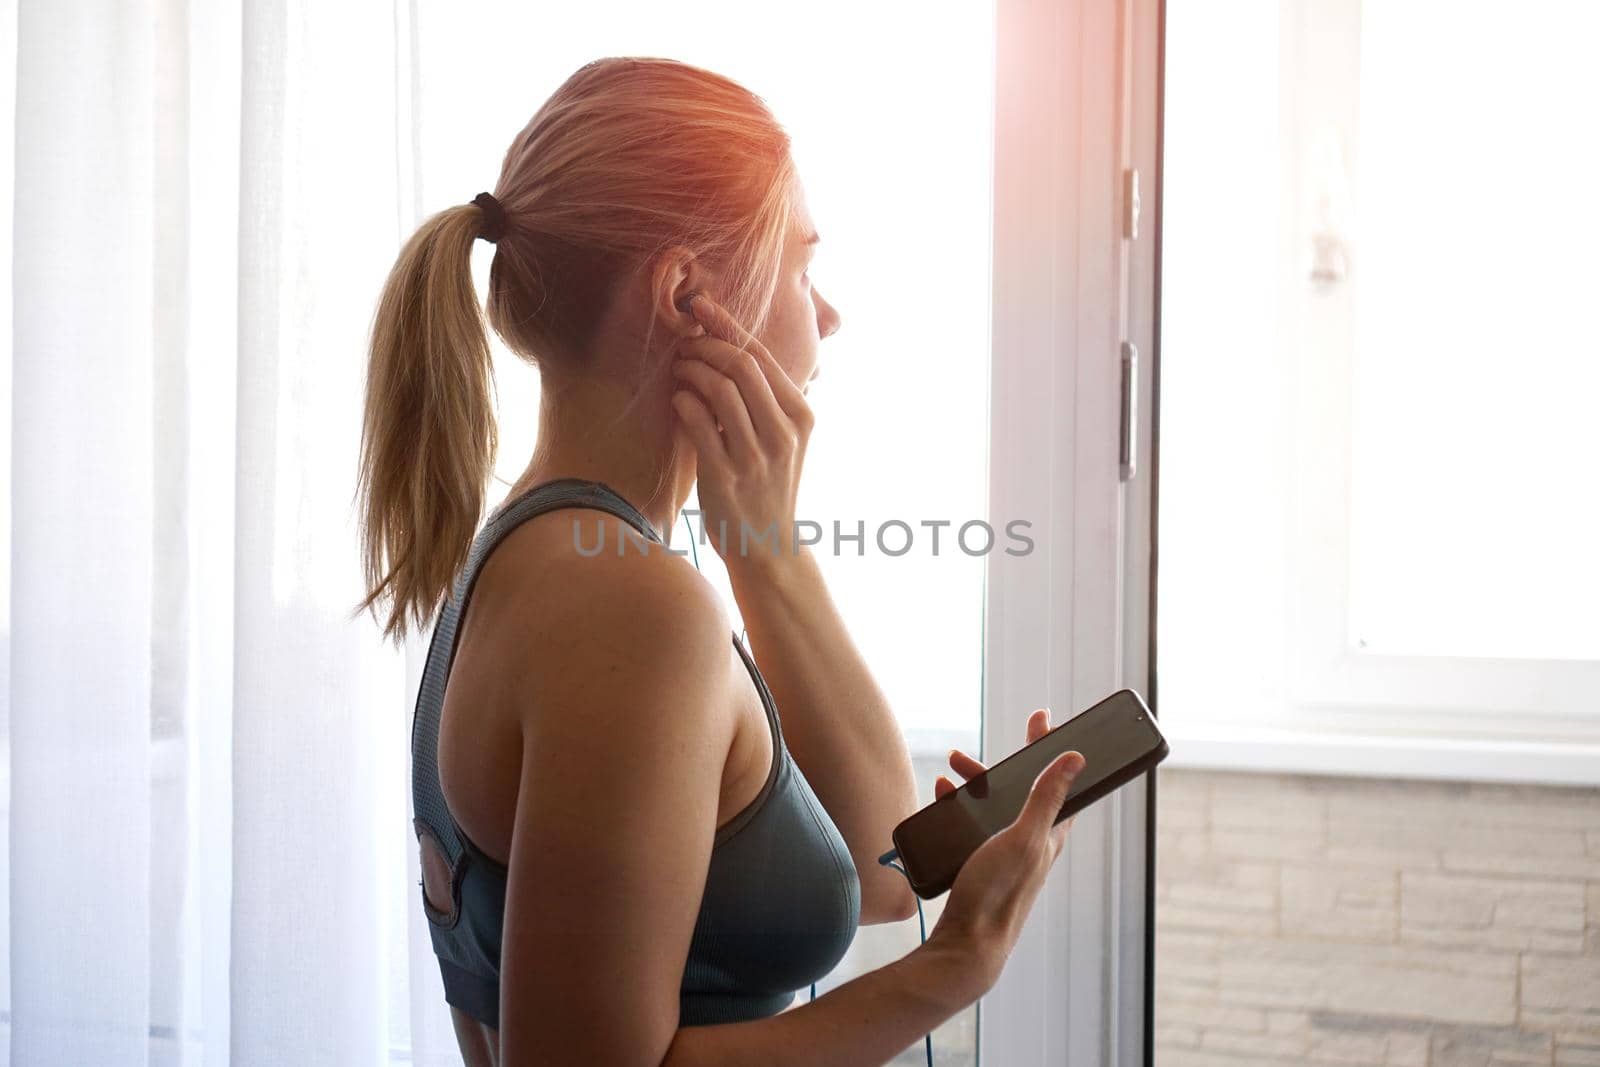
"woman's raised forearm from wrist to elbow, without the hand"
728,545,918,925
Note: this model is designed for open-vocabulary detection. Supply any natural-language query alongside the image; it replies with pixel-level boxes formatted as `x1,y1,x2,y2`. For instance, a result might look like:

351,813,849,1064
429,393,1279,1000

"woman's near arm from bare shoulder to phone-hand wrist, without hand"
499,552,972,1067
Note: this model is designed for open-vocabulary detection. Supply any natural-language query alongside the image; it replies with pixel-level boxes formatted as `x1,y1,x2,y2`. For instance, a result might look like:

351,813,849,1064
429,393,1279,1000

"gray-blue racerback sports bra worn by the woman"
411,478,861,1029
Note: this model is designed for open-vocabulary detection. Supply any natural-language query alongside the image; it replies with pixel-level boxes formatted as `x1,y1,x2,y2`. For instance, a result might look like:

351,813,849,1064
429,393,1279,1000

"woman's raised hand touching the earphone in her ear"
672,293,813,571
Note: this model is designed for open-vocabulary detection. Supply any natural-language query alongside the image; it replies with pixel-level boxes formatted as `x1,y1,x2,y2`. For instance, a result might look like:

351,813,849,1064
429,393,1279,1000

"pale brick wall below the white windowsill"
1155,769,1600,1067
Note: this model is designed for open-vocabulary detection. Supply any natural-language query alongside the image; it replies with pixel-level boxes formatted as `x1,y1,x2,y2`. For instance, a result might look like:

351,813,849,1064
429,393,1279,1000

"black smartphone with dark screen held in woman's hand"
894,689,1166,899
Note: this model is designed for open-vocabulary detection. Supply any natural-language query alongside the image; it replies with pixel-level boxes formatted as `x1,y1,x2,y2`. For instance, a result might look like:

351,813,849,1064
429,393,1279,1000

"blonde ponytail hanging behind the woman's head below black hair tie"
352,205,499,645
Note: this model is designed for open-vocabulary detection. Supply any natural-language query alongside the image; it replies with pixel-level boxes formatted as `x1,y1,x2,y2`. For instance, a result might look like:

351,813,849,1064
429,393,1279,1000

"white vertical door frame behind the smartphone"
978,0,1163,1065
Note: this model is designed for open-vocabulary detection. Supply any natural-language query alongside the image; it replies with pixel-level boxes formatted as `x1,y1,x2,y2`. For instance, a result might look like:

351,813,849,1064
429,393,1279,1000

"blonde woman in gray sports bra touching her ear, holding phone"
360,58,1082,1065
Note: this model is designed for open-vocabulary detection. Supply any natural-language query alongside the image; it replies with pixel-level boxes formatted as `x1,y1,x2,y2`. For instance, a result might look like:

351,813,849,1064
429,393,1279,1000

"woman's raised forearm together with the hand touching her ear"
672,293,917,923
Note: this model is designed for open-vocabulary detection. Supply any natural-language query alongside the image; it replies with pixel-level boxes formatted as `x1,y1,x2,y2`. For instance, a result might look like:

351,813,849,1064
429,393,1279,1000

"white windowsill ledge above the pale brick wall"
1162,726,1600,785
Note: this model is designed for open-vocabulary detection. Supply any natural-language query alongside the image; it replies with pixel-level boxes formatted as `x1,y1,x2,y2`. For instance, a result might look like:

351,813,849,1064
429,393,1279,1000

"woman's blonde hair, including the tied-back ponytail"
352,58,795,643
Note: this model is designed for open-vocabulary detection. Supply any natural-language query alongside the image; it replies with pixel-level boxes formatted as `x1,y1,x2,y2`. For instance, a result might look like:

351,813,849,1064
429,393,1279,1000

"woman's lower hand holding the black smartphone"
928,709,1083,992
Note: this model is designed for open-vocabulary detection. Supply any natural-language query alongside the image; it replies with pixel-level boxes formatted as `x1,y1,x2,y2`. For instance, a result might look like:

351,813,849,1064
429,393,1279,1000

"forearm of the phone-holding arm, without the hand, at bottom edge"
661,944,984,1067
